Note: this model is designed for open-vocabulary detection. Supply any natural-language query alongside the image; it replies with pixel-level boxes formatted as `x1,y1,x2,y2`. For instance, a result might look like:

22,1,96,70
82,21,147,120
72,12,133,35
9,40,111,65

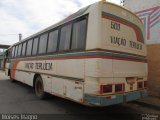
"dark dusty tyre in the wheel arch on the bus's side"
34,76,46,99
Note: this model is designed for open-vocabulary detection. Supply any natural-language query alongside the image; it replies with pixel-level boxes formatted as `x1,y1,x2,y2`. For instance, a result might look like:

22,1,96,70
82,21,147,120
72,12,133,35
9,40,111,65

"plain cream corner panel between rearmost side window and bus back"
86,2,101,50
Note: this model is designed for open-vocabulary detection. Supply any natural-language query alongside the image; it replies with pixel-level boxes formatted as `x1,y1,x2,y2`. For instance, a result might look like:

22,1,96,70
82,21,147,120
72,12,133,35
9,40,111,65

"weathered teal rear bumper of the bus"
85,90,148,106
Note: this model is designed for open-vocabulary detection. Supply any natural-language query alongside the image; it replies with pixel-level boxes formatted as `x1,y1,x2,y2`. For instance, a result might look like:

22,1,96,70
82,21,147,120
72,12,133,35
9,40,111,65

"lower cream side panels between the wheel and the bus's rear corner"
42,75,83,102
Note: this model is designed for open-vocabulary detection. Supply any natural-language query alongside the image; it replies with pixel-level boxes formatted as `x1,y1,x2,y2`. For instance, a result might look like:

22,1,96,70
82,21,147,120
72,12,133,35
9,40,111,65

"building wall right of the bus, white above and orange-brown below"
123,0,160,97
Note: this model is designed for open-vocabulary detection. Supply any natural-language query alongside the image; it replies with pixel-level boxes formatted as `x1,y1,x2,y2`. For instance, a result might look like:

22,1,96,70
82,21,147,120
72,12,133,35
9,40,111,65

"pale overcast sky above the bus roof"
0,0,120,45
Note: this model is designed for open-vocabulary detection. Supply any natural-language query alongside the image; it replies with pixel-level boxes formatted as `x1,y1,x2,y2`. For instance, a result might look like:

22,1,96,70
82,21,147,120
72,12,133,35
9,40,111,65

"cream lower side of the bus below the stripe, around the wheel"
12,59,84,103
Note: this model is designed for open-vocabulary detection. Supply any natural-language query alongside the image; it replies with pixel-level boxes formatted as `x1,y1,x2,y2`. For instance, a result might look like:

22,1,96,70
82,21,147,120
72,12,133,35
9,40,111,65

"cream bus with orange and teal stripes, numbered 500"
5,1,147,106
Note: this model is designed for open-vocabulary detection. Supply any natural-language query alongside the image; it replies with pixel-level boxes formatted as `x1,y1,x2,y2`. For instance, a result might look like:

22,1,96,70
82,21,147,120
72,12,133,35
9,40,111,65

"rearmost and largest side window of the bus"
71,19,87,50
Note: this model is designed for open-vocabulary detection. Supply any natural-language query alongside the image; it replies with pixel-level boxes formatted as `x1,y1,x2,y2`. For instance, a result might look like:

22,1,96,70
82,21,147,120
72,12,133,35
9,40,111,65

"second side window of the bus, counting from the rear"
59,24,72,51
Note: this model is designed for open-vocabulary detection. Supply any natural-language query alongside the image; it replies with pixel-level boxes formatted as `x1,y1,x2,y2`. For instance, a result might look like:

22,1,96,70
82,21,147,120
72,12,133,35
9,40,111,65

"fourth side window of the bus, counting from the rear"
38,33,48,54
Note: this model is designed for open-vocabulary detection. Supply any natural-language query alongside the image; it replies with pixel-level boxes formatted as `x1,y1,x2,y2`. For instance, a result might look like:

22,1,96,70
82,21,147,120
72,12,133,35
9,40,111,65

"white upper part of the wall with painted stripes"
124,0,160,44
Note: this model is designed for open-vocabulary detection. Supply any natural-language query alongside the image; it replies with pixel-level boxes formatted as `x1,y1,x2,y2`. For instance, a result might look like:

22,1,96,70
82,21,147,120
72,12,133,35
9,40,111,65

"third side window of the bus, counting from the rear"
47,30,58,53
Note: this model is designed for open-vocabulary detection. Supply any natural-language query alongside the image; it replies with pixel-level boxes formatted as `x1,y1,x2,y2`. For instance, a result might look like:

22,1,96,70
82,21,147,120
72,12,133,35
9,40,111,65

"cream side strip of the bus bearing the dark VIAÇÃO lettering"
12,58,84,79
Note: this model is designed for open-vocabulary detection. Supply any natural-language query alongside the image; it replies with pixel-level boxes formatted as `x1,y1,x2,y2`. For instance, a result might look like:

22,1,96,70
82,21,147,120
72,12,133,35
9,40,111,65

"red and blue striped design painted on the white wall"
136,6,160,40
